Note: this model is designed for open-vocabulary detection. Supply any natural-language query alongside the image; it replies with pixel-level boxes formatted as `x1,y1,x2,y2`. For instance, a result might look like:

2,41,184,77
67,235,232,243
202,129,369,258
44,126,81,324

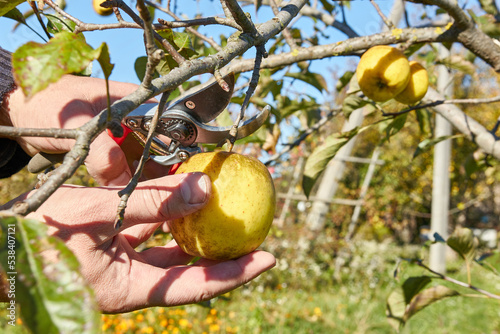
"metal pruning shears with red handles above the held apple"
28,73,270,173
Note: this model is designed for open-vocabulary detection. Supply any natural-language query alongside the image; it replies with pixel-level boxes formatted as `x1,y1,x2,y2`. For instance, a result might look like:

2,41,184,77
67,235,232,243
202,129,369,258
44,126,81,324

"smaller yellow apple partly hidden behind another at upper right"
394,61,429,105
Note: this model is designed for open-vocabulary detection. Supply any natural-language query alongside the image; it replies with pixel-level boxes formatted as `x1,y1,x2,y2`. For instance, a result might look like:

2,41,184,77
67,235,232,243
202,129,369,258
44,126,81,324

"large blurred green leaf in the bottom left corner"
0,216,100,334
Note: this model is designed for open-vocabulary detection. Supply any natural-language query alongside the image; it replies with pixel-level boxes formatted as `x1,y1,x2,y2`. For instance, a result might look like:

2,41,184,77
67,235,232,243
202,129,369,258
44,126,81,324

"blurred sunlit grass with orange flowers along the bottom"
0,174,500,334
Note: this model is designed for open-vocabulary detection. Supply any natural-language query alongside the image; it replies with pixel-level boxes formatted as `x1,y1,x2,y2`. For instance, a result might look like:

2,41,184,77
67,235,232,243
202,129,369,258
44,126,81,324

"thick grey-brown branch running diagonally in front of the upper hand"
8,0,306,215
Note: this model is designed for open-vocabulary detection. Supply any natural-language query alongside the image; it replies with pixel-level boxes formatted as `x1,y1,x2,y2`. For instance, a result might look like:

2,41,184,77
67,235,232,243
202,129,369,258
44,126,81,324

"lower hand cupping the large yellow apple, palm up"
11,173,275,313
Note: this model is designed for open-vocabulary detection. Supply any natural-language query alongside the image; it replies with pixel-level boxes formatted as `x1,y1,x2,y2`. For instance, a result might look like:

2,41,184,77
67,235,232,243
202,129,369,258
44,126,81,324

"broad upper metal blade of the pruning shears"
166,72,235,123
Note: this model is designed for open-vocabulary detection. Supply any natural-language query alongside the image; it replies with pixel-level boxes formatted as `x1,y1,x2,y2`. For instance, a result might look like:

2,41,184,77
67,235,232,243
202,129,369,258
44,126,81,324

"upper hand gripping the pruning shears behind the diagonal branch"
7,75,164,185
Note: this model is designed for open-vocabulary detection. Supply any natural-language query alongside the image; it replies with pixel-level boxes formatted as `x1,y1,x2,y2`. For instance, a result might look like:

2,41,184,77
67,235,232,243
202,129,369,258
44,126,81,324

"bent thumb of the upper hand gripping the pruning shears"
85,132,132,186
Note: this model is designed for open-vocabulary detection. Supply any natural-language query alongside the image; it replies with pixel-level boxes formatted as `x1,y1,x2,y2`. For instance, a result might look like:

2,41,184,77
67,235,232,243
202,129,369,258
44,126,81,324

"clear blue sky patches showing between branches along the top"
0,0,398,84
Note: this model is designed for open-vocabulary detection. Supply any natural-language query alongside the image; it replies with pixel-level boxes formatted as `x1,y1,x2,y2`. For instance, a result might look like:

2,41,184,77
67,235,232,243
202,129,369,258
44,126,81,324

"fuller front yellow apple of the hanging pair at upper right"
356,45,410,102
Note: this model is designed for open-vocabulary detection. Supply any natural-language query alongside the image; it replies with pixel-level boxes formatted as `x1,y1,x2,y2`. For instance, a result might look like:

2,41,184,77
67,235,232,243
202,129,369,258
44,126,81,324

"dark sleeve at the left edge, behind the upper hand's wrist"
0,48,30,179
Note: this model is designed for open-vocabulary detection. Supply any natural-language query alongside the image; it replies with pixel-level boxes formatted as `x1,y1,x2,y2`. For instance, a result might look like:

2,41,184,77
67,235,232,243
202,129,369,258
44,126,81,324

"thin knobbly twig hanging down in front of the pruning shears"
115,91,170,230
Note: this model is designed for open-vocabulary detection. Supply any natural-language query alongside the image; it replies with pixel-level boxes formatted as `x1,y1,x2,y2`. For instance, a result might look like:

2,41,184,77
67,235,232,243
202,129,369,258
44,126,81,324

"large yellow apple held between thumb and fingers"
169,151,276,260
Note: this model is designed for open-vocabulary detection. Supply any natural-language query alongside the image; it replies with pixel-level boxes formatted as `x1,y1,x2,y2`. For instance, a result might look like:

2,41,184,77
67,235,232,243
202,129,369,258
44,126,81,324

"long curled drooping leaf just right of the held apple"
302,134,354,197
